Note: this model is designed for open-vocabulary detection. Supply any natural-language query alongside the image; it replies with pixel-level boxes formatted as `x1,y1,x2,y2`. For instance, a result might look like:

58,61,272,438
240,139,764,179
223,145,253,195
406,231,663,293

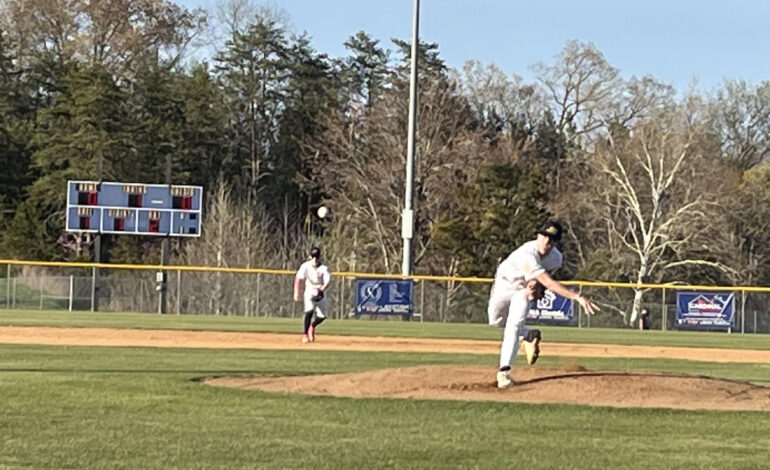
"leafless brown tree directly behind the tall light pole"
303,76,486,272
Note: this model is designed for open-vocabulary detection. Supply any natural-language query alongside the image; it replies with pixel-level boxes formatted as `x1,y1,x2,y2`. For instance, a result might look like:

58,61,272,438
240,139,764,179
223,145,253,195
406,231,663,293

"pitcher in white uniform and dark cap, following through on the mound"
487,221,599,388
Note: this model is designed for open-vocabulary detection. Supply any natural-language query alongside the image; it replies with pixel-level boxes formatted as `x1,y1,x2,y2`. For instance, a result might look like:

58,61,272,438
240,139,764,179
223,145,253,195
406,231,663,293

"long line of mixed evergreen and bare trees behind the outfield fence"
0,0,770,324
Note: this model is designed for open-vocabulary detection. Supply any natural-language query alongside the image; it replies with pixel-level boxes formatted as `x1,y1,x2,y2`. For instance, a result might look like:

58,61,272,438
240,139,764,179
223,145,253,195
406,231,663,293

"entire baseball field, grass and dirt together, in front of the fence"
0,310,770,470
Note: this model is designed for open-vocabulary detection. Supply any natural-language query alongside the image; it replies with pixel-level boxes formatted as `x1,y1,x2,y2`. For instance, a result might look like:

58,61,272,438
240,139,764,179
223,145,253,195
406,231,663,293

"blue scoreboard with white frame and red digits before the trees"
67,181,203,237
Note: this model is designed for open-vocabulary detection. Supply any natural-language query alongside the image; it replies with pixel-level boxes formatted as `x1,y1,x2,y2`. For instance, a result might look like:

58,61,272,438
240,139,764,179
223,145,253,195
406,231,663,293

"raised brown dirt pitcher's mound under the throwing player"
205,366,770,411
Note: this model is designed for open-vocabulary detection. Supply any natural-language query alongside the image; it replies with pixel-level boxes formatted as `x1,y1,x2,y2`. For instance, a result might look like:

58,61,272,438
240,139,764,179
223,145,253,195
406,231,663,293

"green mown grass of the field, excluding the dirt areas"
0,311,770,470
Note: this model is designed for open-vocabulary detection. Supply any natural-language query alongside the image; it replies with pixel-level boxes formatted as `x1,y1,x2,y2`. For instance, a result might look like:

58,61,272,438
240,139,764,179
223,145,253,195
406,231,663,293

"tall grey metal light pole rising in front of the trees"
401,0,420,276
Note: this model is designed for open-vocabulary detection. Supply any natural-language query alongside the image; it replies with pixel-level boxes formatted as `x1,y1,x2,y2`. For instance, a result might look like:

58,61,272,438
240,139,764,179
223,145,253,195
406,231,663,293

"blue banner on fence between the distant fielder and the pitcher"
355,279,414,315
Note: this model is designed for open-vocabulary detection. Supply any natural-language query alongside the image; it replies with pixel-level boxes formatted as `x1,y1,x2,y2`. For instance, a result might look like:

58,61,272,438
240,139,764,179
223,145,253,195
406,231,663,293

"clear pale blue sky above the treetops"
175,0,770,91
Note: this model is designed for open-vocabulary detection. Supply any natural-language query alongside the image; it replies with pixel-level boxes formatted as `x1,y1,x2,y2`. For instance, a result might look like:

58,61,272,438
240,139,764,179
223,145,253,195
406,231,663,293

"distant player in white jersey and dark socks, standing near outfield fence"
294,246,331,343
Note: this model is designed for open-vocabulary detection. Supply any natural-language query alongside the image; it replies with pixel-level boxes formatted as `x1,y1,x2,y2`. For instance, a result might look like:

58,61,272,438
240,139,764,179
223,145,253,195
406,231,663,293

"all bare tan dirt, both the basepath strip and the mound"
0,327,770,411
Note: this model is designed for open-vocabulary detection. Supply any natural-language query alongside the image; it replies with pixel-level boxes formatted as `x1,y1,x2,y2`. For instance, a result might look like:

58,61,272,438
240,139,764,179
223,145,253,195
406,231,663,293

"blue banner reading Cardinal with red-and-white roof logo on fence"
674,292,735,329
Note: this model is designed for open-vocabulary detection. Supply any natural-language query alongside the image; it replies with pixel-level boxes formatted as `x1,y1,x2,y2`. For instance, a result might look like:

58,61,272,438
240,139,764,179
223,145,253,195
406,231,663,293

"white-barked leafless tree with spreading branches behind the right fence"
583,98,730,322
